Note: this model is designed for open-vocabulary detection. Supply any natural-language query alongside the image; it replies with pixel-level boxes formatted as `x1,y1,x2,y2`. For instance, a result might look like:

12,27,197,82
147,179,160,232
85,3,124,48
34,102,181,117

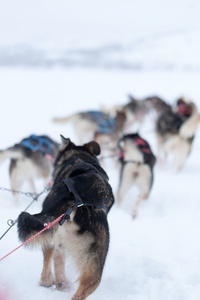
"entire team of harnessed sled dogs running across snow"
0,96,200,300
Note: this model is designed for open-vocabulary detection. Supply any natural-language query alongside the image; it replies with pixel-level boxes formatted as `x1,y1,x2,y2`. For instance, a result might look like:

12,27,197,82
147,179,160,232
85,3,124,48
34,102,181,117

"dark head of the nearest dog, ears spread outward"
55,135,101,165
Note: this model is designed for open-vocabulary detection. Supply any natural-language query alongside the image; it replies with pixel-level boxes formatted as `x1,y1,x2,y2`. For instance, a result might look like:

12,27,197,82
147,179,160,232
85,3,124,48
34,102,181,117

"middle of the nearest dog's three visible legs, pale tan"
54,245,69,291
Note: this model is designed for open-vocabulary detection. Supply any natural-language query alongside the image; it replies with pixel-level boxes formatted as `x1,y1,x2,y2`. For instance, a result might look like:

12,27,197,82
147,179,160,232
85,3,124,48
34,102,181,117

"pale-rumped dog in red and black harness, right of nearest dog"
117,133,156,217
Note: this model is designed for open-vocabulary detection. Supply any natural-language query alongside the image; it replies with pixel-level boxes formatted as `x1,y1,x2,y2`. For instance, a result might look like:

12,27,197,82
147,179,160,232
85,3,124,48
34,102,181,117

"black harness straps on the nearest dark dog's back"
59,162,107,226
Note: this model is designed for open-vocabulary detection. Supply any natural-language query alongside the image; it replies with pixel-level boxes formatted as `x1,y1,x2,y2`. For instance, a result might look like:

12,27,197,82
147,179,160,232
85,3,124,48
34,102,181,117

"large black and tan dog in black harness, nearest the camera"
18,137,114,300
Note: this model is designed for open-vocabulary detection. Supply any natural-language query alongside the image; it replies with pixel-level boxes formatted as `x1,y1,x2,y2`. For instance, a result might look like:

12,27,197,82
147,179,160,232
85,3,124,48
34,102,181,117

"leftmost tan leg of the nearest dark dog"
40,248,54,287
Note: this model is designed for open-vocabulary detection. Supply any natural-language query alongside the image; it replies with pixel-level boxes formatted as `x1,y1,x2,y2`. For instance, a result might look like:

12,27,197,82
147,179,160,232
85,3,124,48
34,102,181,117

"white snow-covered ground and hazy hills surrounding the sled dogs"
0,0,200,300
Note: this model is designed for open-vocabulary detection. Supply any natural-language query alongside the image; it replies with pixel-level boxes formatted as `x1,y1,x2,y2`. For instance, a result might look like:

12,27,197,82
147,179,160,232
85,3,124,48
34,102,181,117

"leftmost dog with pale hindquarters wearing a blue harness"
0,135,59,202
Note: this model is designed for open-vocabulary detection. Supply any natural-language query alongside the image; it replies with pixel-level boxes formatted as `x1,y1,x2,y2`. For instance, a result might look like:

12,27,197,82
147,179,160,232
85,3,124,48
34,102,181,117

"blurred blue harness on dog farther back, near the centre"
88,111,116,134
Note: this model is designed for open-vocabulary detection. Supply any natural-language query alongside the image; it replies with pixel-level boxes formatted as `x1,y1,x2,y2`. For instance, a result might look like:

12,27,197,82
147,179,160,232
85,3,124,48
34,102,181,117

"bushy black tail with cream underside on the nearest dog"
17,212,52,246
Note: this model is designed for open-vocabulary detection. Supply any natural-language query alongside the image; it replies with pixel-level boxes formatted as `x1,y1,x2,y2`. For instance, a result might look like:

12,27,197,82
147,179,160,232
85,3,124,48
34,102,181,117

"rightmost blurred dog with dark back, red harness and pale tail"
156,98,200,171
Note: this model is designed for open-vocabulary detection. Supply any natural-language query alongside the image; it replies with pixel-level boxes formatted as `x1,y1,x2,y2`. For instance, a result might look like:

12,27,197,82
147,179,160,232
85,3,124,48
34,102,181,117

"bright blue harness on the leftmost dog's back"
20,134,51,154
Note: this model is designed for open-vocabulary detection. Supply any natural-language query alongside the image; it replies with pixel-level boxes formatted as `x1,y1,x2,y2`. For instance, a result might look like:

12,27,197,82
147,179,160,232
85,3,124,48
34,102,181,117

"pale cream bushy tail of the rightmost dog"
180,114,200,139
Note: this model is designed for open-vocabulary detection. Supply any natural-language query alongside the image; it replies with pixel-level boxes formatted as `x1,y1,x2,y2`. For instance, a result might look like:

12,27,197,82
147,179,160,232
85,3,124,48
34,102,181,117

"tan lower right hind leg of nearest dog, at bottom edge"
72,267,101,300
